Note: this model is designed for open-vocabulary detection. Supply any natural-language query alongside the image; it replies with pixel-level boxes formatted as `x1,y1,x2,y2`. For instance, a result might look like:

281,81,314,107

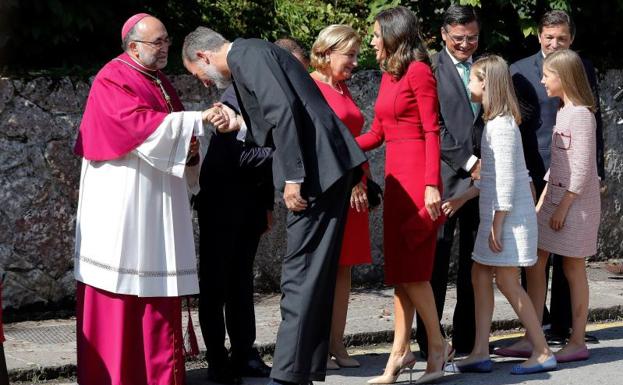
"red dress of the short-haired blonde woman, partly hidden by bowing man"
314,79,372,265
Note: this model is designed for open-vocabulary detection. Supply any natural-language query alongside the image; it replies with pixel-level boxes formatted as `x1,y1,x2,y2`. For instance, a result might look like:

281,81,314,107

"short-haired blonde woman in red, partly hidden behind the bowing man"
311,24,372,369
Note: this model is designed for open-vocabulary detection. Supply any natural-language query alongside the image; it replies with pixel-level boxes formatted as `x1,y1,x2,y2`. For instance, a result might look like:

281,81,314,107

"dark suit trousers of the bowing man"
270,173,352,383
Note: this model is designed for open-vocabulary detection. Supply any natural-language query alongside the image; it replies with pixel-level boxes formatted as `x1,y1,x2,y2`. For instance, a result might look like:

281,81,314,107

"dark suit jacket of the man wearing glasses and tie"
432,47,484,198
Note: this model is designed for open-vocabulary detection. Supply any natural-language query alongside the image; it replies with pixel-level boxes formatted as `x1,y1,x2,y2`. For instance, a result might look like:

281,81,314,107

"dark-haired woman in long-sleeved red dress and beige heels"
357,7,451,384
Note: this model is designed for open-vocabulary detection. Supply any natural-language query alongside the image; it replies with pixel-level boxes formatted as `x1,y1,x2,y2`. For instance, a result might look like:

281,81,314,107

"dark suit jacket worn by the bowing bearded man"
227,39,366,196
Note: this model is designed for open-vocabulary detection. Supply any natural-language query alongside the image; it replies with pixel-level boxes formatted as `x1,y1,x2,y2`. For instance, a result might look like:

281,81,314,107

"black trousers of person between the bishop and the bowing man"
199,207,261,365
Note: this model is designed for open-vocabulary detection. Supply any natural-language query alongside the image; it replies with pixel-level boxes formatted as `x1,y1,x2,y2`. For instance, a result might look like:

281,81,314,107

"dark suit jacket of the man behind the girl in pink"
510,51,605,192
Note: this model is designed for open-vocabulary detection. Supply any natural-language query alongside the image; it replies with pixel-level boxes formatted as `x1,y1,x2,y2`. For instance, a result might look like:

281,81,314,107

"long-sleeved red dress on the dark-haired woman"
357,61,441,285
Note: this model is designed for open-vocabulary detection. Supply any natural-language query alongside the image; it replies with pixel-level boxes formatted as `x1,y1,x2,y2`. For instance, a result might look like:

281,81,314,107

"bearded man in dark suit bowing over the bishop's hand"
183,27,366,384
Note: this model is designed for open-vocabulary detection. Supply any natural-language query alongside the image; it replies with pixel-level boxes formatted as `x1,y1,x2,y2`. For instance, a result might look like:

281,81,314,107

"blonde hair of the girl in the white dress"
471,55,521,124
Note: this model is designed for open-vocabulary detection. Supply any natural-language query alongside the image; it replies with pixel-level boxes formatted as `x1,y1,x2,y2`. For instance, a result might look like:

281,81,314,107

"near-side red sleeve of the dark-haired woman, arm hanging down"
406,62,441,187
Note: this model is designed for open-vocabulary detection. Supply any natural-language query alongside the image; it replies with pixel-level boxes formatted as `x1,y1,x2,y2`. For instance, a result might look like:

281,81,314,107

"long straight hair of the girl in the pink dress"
543,49,597,112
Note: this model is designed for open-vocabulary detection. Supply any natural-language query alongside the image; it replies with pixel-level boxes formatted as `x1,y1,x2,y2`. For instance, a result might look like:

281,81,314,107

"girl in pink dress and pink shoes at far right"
528,49,601,362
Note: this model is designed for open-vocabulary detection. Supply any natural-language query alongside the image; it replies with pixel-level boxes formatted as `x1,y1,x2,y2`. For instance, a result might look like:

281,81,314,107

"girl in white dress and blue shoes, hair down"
442,55,556,374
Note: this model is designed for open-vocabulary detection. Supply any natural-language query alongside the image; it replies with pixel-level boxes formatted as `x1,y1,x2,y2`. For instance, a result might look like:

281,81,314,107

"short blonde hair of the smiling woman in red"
310,24,361,71
